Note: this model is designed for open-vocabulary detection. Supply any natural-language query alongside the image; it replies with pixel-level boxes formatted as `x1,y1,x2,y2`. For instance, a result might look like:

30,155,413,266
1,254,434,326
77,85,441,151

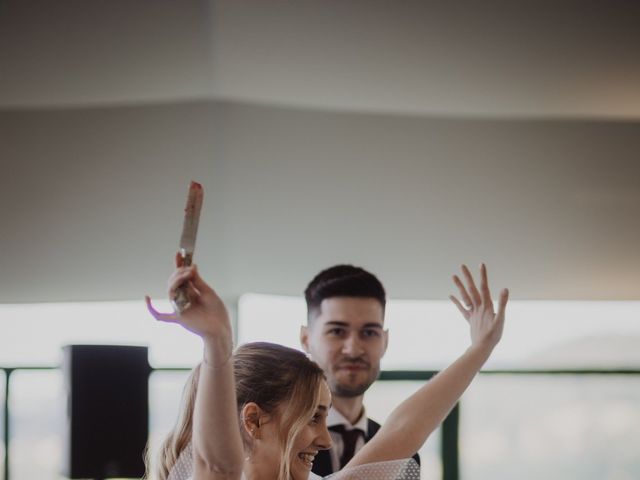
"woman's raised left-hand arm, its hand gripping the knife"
147,256,244,480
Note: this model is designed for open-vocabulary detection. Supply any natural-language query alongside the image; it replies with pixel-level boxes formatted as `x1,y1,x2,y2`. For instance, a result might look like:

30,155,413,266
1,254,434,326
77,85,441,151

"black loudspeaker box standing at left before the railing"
63,345,151,479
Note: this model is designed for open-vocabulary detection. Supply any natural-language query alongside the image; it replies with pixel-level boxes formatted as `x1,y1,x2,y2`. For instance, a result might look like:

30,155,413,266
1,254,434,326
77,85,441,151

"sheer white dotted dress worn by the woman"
168,444,420,480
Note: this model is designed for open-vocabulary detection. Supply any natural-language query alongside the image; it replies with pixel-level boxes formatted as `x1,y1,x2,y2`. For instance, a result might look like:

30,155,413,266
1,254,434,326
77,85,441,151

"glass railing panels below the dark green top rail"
0,366,640,480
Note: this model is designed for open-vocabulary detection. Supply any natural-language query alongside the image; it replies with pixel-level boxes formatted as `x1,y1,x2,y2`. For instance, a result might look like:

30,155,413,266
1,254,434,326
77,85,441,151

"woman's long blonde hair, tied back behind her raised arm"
147,342,324,480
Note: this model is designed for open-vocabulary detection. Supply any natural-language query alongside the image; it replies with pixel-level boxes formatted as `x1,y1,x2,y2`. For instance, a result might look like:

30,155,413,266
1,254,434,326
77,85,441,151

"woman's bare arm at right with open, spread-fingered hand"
348,264,509,466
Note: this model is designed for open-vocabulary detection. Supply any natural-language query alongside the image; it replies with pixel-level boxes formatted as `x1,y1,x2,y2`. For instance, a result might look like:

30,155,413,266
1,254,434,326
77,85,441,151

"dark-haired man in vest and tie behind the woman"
300,265,420,476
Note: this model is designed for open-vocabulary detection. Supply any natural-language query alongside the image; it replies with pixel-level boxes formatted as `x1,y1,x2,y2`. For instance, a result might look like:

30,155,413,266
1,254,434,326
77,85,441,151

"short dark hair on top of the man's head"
304,265,387,319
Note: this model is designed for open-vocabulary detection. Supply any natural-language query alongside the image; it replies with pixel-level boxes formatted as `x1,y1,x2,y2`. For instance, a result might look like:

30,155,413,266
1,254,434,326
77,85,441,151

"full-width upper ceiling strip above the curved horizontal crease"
0,0,640,119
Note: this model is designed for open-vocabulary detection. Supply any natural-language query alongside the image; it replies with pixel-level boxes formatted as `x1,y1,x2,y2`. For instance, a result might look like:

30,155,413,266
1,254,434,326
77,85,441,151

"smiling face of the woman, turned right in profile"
291,380,331,480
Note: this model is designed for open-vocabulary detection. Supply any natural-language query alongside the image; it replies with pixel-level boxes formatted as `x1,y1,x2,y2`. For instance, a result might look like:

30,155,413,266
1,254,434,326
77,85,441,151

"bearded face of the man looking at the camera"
300,297,388,397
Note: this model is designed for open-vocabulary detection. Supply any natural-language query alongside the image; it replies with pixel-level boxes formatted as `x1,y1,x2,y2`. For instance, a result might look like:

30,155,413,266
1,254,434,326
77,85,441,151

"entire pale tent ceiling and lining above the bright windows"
0,0,640,302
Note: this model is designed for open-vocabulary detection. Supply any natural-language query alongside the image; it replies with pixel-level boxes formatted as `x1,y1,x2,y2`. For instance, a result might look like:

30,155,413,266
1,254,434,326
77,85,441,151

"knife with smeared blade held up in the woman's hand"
172,181,204,313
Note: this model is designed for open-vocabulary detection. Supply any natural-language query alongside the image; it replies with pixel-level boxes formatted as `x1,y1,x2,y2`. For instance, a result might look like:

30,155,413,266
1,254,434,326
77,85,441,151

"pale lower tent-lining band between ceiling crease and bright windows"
0,103,640,302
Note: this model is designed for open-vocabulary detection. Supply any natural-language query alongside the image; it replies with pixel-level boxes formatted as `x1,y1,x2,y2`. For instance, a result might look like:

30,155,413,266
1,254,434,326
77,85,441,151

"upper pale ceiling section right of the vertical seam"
213,0,640,118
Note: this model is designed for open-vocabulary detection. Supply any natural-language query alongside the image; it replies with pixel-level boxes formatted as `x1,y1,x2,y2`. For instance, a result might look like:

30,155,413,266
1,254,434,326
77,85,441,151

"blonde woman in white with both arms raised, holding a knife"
147,256,508,480
